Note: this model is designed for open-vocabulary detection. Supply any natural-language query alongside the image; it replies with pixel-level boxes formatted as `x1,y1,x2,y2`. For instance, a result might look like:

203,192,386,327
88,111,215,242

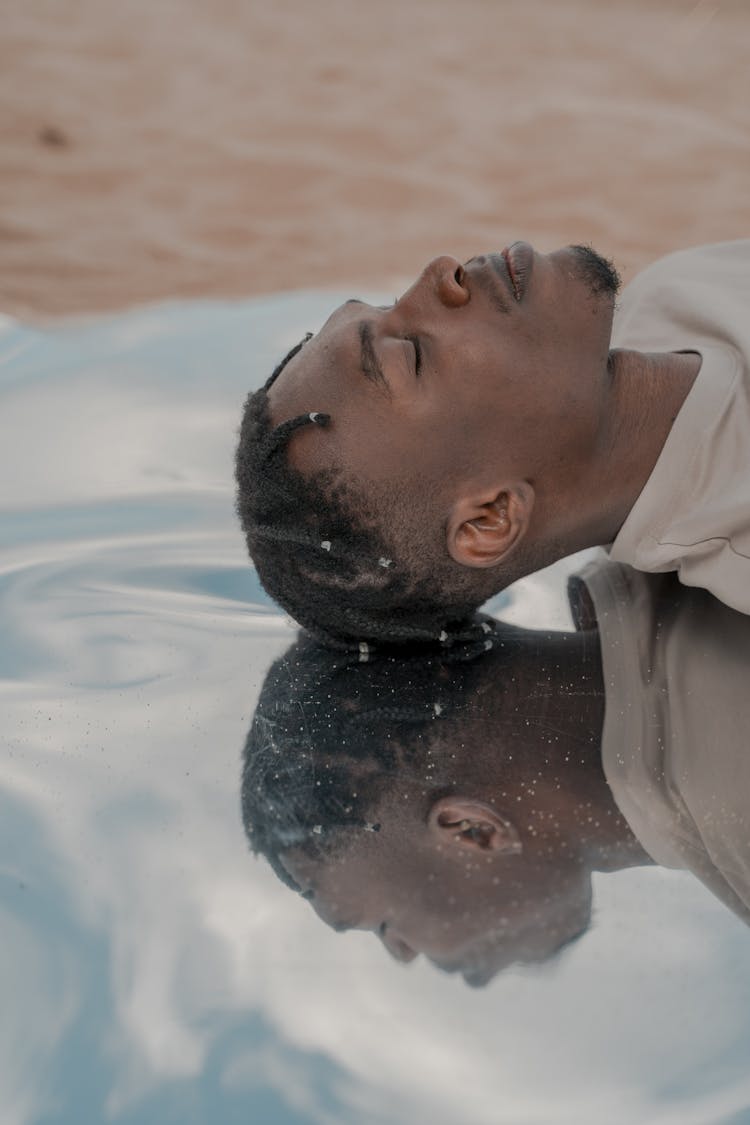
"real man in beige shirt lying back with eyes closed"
236,242,750,645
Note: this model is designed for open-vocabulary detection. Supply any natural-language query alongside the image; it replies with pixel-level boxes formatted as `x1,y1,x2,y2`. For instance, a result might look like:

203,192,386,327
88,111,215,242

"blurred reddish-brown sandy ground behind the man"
0,0,750,316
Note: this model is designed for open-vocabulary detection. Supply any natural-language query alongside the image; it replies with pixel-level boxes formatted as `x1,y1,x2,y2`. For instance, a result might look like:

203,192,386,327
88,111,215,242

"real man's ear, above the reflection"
448,480,534,567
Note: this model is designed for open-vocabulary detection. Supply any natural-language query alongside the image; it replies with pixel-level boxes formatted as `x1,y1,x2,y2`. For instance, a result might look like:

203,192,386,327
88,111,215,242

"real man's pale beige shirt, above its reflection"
612,241,750,613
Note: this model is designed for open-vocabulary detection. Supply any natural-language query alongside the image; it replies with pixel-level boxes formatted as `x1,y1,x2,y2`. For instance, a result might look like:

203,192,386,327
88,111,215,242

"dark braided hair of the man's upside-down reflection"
242,619,507,885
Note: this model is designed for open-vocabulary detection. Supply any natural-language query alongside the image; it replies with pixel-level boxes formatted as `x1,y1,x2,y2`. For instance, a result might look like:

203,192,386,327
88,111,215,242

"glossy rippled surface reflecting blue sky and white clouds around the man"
0,294,750,1125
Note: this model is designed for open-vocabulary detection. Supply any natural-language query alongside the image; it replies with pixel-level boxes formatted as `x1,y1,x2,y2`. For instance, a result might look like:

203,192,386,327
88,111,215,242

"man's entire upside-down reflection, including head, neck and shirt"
242,564,750,984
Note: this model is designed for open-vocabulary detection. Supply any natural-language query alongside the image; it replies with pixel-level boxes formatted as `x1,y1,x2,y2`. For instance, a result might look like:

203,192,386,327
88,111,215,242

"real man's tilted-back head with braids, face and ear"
237,243,617,641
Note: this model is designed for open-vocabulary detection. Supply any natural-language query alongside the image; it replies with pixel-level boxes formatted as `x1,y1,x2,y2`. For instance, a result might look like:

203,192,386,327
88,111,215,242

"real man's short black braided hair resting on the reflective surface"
235,341,503,646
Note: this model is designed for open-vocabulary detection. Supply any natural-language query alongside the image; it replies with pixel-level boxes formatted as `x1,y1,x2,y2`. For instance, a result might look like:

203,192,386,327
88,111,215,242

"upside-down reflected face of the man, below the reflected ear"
282,796,590,987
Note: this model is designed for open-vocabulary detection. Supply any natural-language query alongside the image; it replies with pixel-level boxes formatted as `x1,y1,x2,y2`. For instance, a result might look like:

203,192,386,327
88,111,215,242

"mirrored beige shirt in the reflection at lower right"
582,561,750,924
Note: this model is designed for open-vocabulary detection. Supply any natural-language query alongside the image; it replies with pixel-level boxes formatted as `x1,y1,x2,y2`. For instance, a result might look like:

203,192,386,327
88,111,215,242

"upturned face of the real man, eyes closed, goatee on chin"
270,243,616,508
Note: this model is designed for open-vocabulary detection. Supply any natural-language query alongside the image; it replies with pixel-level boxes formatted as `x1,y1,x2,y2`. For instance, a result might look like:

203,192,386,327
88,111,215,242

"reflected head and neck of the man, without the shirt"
243,624,645,984
